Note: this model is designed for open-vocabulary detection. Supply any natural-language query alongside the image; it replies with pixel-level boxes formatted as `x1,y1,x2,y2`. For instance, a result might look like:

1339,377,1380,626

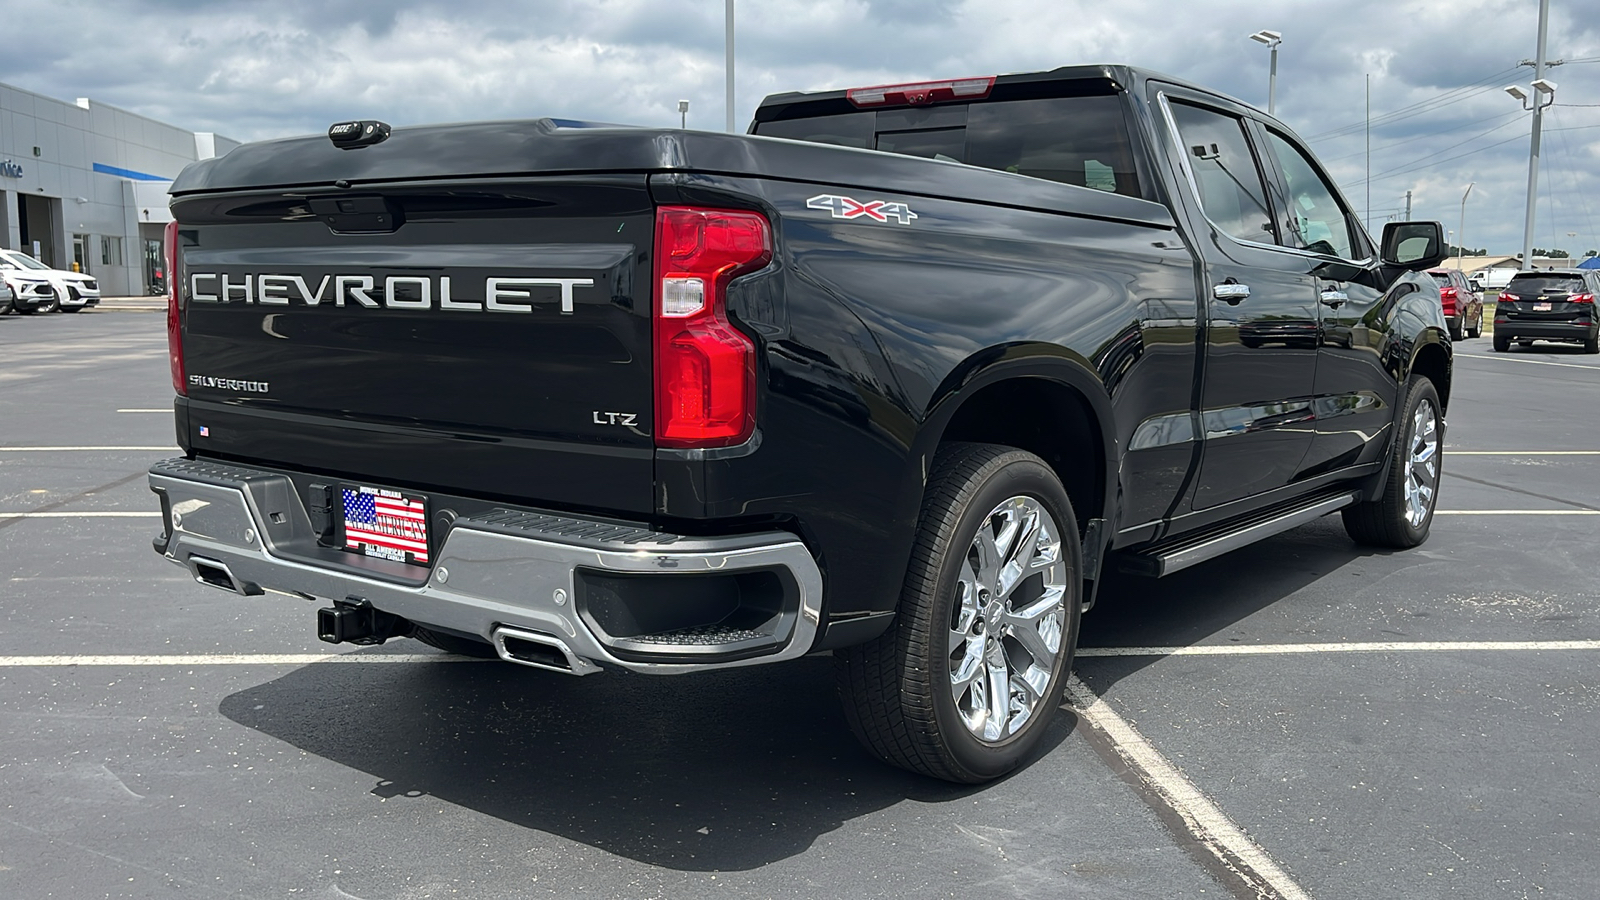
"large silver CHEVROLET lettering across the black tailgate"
189,272,595,315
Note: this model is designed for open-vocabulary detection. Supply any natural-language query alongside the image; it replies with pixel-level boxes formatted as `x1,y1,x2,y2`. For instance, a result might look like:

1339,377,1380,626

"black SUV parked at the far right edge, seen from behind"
1494,269,1600,354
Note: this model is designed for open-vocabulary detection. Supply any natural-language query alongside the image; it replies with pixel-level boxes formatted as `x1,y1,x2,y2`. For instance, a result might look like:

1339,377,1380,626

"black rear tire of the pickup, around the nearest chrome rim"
835,444,1083,783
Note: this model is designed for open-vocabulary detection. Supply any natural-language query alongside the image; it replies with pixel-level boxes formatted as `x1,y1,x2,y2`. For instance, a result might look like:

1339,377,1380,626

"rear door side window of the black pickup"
1171,102,1277,243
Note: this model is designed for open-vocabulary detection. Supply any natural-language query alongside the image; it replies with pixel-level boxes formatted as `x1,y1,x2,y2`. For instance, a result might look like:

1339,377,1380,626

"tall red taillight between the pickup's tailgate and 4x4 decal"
654,207,773,447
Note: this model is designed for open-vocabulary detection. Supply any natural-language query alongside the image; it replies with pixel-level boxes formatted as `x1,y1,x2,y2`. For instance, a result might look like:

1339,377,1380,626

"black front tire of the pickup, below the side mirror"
1341,375,1445,549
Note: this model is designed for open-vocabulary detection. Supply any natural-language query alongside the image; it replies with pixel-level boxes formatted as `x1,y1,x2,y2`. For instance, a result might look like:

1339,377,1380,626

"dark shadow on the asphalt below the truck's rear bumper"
221,647,1077,871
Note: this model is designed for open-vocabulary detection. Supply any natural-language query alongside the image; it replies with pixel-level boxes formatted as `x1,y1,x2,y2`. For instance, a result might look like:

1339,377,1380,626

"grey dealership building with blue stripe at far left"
0,85,238,296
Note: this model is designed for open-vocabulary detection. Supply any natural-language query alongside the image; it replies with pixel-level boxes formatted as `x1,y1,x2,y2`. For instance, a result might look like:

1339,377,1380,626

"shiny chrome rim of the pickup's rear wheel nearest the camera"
949,496,1067,743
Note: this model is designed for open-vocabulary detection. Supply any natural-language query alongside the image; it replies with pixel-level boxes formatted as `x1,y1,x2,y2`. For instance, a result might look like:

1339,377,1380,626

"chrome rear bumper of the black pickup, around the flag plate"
150,460,822,674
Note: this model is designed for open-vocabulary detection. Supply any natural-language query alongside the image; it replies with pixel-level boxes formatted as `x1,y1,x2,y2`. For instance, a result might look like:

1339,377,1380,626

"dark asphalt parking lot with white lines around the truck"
0,304,1600,900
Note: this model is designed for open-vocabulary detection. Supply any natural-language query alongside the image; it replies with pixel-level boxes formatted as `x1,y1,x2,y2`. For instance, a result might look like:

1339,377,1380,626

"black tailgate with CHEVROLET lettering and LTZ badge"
174,176,653,512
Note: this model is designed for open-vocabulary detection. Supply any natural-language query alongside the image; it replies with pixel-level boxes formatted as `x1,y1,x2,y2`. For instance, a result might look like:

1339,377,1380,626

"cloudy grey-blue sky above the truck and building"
0,0,1600,256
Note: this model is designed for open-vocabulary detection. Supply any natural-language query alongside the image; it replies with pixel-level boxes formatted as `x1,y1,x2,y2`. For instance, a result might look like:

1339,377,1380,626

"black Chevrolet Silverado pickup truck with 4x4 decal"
150,66,1451,781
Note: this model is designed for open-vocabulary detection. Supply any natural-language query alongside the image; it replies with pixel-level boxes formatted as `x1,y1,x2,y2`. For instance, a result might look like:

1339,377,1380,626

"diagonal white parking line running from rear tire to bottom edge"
1067,677,1310,900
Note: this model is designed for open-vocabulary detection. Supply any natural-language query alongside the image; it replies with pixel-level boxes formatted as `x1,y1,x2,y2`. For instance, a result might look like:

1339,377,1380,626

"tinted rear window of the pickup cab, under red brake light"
755,96,1142,197
